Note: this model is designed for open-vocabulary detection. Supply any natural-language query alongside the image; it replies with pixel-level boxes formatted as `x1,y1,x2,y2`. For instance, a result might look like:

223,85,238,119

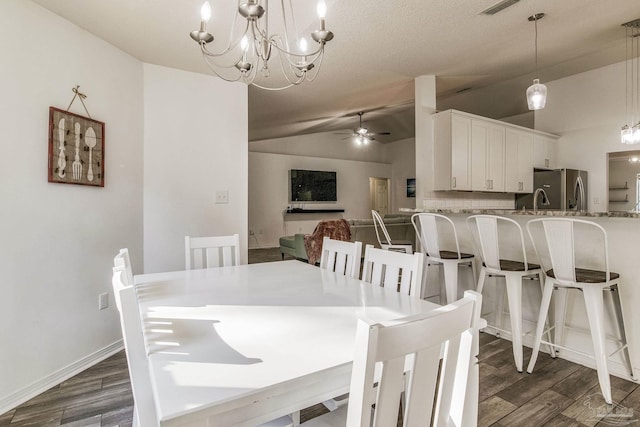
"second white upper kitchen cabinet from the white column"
471,119,505,192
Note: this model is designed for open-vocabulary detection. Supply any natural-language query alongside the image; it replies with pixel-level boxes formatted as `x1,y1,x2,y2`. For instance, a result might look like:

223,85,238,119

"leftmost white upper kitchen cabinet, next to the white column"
433,110,471,191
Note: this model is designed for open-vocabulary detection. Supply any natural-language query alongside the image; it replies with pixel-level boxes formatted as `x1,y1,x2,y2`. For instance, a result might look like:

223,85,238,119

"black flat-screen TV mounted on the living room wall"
289,169,338,202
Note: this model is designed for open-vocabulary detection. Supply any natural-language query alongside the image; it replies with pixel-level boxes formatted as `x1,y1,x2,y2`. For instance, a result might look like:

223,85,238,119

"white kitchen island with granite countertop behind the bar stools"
401,209,640,379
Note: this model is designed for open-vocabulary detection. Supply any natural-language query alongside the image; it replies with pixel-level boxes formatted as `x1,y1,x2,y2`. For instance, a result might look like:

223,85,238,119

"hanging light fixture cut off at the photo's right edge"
620,19,640,144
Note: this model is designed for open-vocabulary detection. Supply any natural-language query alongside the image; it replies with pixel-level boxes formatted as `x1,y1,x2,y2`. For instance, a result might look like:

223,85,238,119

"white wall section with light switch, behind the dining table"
144,64,248,273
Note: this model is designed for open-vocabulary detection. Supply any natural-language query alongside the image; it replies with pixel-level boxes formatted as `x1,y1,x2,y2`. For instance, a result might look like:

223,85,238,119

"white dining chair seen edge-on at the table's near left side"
112,249,300,427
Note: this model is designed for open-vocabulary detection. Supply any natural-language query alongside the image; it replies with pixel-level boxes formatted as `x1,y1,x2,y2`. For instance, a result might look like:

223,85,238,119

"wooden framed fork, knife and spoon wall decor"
49,107,104,187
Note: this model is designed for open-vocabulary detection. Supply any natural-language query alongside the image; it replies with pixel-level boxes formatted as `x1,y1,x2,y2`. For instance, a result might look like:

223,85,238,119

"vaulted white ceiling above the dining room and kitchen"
33,0,640,142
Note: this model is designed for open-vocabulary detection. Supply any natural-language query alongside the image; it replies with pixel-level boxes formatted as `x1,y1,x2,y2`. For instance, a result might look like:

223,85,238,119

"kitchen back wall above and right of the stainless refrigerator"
535,62,637,212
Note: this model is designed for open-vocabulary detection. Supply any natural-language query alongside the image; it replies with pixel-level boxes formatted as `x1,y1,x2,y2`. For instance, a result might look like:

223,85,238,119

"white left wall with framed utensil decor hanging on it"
0,0,143,413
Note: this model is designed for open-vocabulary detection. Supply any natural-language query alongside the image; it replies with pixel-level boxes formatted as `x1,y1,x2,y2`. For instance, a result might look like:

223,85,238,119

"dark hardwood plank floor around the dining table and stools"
0,249,640,427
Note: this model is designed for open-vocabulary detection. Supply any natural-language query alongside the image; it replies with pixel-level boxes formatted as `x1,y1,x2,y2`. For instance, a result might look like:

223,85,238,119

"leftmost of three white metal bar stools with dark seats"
411,213,477,304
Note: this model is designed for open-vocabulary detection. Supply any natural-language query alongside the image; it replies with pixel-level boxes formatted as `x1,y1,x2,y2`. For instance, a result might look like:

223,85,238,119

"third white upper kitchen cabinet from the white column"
504,128,534,193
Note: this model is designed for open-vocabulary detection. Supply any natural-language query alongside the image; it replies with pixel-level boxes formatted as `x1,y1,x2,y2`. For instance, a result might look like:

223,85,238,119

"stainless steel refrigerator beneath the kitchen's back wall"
516,169,588,211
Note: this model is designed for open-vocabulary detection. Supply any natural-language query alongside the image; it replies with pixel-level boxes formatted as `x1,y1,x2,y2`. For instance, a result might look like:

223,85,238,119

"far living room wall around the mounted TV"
249,152,392,248
